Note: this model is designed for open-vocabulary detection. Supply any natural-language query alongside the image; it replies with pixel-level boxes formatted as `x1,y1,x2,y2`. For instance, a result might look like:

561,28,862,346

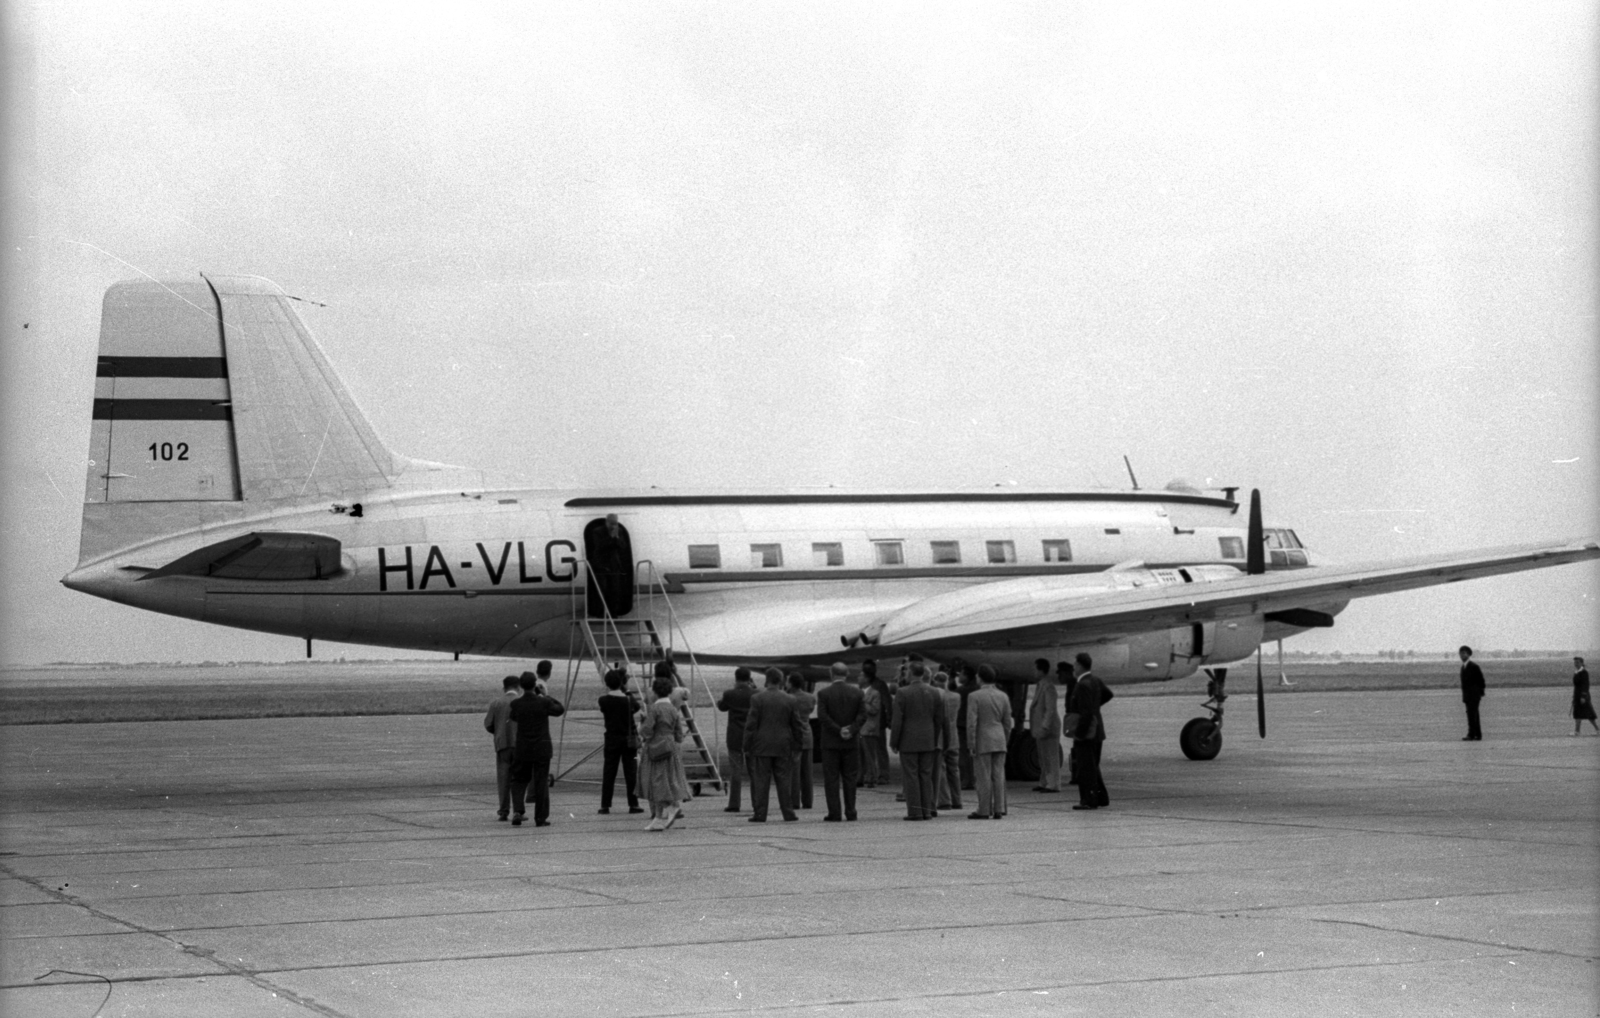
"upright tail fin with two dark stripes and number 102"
80,275,403,560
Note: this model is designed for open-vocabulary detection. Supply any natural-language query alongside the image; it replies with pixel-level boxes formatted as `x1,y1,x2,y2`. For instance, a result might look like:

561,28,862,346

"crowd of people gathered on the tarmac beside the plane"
483,655,1112,831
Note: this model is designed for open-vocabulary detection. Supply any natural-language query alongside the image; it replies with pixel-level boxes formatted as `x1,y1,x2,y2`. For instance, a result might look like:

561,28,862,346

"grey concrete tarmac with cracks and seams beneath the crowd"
0,687,1600,1018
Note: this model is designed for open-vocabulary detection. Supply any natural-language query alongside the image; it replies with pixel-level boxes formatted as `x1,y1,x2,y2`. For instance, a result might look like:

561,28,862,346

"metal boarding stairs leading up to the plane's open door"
552,559,726,796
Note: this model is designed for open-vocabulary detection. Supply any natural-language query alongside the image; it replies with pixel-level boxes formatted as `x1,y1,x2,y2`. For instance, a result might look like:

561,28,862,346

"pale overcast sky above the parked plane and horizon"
0,2,1600,663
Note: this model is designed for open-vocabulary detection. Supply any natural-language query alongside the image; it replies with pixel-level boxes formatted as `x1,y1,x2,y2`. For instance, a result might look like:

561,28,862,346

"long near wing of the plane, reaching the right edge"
875,539,1600,650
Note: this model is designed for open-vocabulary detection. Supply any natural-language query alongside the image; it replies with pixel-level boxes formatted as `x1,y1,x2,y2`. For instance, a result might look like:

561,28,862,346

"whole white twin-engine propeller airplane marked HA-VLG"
62,274,1600,760
